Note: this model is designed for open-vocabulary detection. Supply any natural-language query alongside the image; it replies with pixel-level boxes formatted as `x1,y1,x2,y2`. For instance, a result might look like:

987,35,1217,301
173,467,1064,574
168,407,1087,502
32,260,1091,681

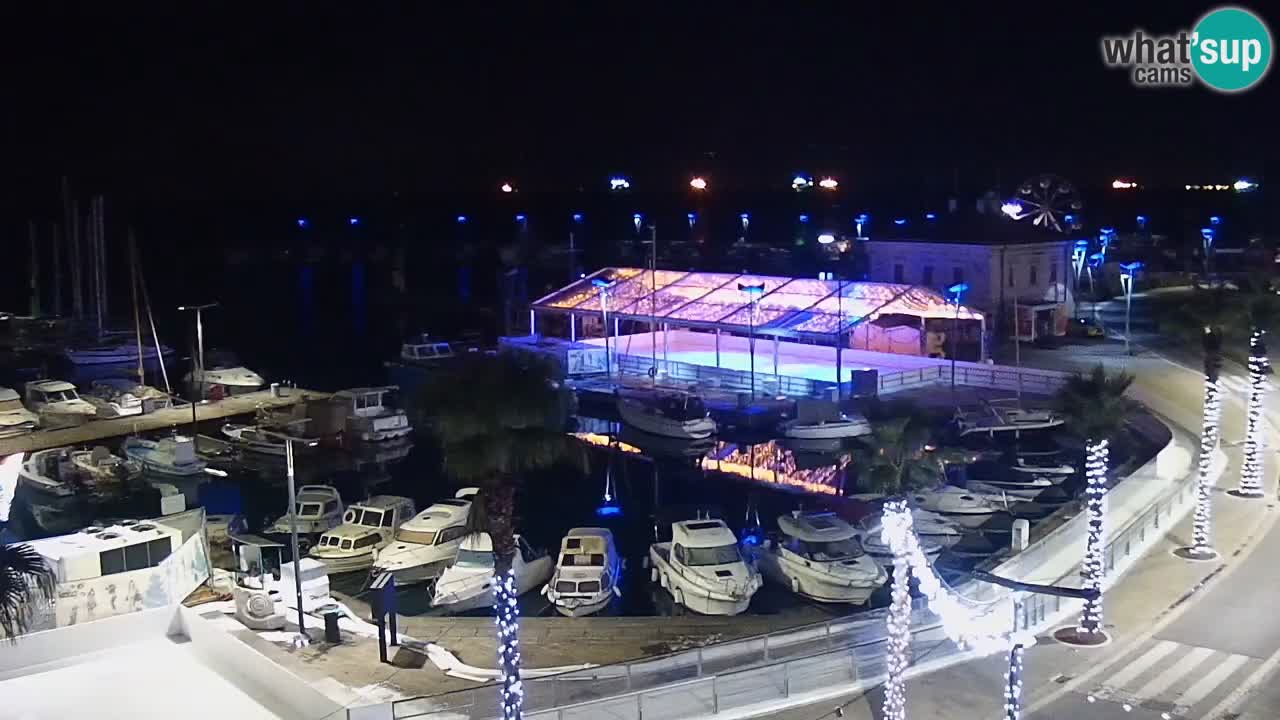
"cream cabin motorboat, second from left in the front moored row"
311,495,413,574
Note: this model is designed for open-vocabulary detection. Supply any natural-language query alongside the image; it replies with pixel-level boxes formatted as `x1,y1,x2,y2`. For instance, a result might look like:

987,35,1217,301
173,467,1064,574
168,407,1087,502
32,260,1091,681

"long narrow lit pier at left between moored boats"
0,388,329,457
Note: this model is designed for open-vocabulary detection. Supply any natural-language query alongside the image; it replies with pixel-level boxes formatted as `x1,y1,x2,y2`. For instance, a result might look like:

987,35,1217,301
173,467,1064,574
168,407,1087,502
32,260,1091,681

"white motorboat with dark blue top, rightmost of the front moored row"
748,512,888,605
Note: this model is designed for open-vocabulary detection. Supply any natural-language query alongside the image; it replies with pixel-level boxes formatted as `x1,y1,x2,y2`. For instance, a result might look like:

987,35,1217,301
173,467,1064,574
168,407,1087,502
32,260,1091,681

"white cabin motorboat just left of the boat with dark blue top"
649,520,760,615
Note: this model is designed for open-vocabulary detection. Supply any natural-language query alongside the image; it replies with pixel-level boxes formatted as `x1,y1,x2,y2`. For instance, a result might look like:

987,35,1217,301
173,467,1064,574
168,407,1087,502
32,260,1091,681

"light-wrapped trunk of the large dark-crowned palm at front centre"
485,486,525,720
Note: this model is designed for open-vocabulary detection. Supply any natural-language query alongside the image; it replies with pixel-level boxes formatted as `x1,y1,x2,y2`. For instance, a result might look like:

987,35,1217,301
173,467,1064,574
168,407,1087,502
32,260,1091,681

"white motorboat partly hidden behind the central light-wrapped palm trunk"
431,533,552,612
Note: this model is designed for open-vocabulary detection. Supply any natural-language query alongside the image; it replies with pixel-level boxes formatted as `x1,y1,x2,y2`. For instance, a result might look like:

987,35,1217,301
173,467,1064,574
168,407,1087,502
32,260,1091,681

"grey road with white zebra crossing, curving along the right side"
774,315,1280,720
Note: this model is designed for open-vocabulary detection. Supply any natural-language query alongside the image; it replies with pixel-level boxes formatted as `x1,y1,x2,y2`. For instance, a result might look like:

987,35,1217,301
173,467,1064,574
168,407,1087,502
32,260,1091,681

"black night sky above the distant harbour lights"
0,1,1280,202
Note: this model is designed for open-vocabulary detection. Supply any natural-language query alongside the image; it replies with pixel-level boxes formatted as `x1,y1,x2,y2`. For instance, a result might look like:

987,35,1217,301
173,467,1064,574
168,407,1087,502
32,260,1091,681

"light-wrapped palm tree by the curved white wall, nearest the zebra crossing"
1055,365,1137,644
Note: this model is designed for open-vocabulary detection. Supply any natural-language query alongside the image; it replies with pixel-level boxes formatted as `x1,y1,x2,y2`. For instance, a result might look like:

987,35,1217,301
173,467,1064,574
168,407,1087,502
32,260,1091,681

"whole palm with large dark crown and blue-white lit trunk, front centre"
419,354,586,720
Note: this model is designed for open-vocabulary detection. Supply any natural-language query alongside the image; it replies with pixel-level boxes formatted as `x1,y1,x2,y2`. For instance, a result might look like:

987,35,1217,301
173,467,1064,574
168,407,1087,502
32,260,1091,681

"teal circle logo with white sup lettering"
1192,8,1271,92
